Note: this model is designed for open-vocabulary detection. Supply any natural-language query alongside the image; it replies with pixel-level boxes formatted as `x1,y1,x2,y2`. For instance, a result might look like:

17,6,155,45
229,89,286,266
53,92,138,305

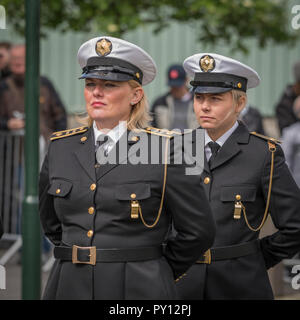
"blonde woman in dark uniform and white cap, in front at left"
40,37,215,299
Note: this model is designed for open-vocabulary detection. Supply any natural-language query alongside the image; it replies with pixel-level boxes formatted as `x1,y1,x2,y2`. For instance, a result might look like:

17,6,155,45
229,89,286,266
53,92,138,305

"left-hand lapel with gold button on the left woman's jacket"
74,128,96,181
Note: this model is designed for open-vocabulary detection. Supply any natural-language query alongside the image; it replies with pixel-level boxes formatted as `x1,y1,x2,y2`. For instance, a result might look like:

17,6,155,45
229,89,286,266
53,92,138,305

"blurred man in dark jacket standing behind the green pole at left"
0,45,67,141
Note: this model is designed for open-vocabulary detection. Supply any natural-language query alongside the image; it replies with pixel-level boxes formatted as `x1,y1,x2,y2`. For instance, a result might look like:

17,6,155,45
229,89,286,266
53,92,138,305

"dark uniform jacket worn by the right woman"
178,123,300,299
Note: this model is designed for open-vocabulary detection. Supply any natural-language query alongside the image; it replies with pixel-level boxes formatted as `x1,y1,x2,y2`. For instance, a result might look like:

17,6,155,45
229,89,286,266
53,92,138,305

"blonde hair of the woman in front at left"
76,80,152,130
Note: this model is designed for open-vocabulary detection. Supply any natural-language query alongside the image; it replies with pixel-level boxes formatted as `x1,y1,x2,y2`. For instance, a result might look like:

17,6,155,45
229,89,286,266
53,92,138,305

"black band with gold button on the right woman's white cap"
190,72,248,92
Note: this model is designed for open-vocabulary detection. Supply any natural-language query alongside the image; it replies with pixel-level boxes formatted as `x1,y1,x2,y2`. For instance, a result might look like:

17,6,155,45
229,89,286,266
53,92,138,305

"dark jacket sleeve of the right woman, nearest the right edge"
260,145,300,268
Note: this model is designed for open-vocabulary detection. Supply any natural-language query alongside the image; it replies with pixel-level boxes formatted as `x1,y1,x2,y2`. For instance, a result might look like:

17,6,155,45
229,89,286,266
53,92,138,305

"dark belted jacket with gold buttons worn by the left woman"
40,125,215,299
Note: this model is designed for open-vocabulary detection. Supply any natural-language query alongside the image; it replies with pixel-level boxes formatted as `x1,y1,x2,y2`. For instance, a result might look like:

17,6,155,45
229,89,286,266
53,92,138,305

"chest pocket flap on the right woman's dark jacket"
221,185,256,202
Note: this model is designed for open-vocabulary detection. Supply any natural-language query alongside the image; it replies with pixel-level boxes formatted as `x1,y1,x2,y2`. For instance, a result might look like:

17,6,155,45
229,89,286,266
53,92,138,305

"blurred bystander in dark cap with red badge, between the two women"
150,64,197,131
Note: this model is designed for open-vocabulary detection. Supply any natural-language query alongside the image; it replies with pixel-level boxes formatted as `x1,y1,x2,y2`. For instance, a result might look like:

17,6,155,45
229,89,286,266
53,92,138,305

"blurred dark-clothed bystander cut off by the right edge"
276,61,300,134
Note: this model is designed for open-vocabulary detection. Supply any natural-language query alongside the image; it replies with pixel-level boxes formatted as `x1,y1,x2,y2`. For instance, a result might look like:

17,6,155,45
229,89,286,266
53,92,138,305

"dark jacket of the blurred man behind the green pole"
0,75,67,140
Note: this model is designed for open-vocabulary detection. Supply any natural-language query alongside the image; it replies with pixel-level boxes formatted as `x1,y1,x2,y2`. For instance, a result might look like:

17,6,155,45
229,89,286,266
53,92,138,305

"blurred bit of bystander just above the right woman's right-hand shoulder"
239,103,265,134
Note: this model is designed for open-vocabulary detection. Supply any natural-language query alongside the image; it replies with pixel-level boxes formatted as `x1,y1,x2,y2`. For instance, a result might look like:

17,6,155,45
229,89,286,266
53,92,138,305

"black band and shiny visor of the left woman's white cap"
80,57,143,84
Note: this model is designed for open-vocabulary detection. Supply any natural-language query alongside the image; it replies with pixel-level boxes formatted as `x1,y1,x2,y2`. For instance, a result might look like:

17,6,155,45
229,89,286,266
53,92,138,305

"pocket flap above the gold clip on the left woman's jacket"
115,183,151,200
